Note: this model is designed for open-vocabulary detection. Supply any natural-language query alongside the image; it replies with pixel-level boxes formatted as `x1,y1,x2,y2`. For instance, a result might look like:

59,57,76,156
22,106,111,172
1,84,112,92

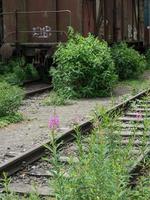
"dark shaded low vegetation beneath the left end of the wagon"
0,57,38,85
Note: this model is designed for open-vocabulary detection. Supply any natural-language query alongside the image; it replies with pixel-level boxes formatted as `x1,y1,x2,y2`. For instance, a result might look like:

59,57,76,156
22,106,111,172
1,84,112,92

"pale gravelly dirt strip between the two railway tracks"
0,71,150,163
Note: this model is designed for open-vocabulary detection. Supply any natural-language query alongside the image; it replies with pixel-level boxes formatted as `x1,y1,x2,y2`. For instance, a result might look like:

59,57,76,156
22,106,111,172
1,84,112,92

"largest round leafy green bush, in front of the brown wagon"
50,31,117,98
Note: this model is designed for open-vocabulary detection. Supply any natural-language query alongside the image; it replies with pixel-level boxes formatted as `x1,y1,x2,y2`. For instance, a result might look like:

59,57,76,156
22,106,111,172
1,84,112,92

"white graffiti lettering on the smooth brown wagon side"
32,26,52,39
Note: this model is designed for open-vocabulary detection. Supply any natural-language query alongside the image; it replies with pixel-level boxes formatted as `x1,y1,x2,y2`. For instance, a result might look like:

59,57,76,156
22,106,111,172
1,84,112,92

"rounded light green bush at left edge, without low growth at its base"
0,82,23,117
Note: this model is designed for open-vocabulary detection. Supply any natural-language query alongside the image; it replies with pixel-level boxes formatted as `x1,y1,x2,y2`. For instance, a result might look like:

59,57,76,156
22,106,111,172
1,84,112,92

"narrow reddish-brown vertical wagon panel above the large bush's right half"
82,0,96,36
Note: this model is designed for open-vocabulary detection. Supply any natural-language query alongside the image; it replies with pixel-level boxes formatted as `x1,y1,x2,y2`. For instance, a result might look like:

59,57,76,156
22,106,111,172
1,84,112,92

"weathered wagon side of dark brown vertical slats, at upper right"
97,0,144,42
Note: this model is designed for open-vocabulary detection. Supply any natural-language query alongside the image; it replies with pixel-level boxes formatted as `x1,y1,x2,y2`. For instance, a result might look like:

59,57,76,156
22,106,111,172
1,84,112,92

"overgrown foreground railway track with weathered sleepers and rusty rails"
0,89,150,196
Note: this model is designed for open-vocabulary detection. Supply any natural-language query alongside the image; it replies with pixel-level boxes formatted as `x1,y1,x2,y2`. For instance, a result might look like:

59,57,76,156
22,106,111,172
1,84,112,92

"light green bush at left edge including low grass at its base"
0,82,24,127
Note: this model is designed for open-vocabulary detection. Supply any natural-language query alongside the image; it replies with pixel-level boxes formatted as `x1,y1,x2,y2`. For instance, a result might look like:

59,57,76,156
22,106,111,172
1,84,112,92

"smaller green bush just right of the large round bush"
112,42,146,80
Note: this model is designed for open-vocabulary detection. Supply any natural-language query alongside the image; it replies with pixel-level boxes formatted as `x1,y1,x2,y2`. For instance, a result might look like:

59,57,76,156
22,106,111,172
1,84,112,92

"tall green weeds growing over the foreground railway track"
1,110,150,200
